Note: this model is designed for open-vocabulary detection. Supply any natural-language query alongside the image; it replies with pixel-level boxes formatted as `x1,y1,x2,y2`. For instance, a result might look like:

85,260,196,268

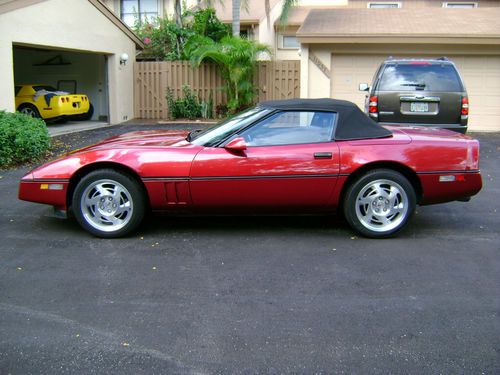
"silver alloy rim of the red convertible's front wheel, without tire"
80,180,134,232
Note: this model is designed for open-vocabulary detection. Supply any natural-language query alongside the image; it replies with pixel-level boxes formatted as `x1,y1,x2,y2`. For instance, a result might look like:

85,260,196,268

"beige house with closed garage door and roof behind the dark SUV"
216,0,500,131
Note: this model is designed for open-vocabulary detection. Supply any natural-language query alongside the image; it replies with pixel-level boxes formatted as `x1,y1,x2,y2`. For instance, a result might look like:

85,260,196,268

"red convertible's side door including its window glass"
190,112,339,210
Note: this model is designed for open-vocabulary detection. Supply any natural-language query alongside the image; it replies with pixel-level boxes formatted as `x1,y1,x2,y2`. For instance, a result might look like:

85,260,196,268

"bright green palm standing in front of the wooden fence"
186,36,270,112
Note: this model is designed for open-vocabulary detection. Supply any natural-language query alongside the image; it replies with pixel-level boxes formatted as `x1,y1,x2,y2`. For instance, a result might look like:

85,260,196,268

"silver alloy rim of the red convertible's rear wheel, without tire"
356,179,409,232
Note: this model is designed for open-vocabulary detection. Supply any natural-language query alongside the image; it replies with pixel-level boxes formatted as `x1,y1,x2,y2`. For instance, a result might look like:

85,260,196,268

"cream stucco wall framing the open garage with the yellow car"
0,0,135,123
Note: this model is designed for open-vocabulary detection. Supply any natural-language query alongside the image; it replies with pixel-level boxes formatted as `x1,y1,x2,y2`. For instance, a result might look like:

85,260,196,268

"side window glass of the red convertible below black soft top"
241,111,337,146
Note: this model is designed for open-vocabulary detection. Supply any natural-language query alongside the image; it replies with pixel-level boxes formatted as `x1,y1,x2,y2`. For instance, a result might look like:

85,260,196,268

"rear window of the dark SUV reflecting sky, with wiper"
378,63,463,92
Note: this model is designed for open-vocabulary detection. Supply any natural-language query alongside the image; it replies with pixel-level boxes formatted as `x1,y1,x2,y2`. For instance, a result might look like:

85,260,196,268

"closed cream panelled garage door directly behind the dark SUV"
331,55,500,131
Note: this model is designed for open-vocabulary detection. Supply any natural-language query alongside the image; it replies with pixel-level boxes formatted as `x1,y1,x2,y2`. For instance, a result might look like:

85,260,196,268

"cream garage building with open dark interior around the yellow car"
0,0,143,123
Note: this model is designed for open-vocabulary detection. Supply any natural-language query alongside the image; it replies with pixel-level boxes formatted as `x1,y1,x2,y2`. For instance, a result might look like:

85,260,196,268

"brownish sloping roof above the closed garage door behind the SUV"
297,8,500,38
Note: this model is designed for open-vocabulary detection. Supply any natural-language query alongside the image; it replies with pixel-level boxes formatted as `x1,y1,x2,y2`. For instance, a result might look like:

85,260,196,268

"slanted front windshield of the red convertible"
191,107,271,147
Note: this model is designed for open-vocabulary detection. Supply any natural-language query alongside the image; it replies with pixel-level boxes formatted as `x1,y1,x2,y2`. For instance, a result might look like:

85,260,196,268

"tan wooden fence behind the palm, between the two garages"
134,61,300,119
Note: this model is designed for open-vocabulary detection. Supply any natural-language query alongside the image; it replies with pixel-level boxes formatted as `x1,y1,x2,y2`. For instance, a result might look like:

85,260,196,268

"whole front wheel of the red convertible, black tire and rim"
72,169,147,238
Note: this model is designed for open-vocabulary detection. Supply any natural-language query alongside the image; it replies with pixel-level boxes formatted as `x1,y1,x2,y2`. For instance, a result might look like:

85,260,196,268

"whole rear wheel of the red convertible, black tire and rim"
343,169,416,238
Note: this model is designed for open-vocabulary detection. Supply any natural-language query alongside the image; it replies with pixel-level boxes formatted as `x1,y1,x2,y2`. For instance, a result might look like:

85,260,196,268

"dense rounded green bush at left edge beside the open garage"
0,111,50,167
